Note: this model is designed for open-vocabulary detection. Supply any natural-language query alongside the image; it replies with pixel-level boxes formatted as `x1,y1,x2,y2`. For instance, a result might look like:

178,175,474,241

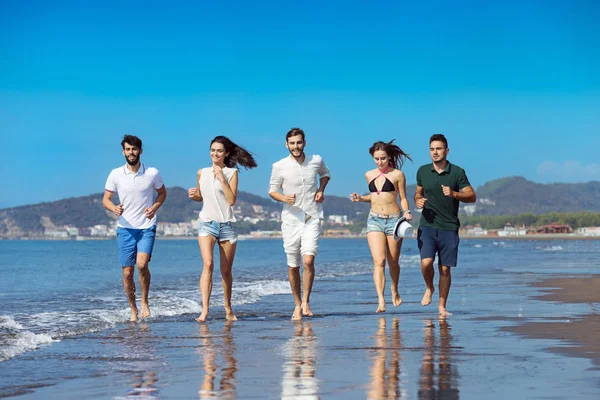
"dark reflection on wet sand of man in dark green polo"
419,318,459,399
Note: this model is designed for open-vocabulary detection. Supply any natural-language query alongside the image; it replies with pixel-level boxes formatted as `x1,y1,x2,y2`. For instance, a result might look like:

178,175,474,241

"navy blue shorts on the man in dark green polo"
417,226,460,267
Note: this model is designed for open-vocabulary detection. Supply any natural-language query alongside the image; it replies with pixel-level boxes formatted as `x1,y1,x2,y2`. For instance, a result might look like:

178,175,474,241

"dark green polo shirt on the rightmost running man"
417,162,471,231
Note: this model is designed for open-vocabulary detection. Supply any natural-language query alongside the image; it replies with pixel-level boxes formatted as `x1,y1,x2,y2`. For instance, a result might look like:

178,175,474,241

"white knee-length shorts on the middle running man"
281,217,321,268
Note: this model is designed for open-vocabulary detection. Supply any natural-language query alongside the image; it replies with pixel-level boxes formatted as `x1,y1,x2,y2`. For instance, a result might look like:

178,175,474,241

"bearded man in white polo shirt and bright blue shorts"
102,135,167,322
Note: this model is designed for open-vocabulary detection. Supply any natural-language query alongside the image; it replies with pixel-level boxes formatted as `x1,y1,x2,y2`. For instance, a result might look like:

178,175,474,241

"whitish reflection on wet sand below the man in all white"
281,321,319,399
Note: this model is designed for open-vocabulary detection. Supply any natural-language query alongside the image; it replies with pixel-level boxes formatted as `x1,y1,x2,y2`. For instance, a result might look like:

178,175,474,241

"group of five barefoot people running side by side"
102,128,476,322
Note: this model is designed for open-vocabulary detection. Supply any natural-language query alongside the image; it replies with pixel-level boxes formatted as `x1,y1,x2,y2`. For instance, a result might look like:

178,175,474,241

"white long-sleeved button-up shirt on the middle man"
269,155,330,224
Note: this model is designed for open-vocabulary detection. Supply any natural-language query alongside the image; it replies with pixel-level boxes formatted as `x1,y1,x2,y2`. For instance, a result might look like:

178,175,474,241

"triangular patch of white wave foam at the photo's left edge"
0,315,56,361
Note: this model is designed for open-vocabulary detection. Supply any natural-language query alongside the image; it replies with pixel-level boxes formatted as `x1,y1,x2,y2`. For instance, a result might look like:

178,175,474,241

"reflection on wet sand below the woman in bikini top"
368,318,406,399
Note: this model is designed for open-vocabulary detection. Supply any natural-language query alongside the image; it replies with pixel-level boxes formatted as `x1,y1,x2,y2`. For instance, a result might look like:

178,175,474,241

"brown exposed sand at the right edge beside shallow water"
504,275,600,369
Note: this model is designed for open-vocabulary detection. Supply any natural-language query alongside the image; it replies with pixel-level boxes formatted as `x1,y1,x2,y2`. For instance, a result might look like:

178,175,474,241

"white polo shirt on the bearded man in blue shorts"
104,164,164,229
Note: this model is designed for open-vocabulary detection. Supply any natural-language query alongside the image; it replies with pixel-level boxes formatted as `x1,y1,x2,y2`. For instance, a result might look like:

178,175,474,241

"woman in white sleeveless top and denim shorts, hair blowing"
188,136,256,322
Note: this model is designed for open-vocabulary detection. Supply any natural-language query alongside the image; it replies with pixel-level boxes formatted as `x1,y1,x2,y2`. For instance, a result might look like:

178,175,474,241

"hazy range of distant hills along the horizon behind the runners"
0,177,600,238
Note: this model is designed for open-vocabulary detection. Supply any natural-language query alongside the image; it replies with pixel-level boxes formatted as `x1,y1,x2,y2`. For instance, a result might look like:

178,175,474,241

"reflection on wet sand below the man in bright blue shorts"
124,323,158,400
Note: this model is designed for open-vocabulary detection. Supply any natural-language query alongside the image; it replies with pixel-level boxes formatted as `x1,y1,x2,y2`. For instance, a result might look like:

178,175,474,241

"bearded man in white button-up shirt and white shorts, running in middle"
269,128,329,320
